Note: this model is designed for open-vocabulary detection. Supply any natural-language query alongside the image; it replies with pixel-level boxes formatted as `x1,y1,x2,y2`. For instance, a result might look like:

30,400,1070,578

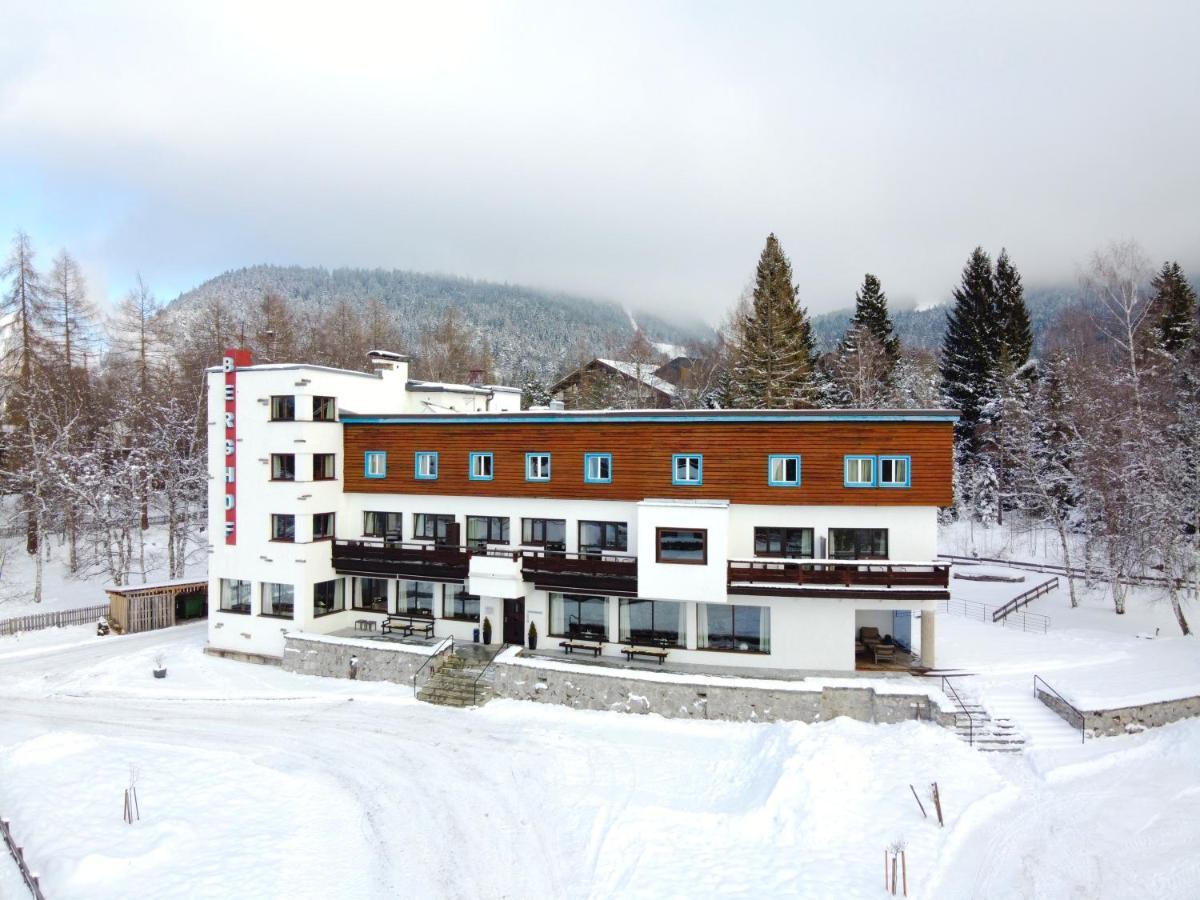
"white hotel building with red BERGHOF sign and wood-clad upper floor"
209,354,955,672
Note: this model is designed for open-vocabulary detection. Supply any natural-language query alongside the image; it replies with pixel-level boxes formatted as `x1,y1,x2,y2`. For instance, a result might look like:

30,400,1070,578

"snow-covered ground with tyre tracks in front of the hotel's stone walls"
0,623,1200,900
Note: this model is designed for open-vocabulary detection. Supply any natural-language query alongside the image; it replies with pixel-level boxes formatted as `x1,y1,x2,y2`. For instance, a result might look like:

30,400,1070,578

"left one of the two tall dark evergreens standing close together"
941,247,1002,456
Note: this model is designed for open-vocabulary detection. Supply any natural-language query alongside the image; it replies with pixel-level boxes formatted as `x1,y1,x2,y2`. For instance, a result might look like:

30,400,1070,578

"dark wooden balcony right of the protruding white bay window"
728,558,950,599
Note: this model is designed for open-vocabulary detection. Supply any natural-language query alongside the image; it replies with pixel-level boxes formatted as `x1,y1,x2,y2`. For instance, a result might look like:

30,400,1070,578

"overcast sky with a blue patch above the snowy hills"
0,0,1200,322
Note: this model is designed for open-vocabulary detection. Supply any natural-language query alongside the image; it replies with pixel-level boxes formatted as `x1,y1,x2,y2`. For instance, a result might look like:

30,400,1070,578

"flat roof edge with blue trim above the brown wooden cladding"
341,409,959,425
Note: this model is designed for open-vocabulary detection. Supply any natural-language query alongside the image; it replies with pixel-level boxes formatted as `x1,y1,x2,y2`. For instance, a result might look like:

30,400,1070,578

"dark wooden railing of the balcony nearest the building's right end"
728,558,950,588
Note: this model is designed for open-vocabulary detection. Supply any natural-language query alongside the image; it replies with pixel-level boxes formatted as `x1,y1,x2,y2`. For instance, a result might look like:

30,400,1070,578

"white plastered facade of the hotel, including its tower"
209,356,937,671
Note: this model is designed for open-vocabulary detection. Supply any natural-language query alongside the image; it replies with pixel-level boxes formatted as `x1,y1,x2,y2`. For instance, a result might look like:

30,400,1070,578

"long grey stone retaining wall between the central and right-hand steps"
493,662,954,727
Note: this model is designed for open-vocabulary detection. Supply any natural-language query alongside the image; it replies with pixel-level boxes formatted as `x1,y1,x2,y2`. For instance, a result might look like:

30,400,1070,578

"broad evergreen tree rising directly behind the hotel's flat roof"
733,234,821,409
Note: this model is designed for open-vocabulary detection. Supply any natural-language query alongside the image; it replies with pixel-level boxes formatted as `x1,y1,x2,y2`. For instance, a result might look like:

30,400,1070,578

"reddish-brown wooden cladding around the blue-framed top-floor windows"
343,421,953,506
